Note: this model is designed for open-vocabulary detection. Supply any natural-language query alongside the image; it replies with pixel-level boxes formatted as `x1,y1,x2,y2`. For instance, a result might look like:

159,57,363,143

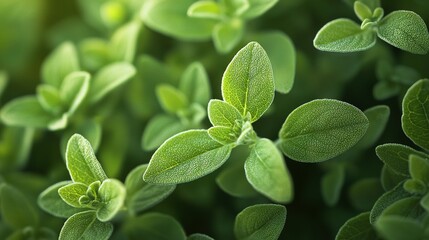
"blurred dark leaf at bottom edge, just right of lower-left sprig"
121,213,186,240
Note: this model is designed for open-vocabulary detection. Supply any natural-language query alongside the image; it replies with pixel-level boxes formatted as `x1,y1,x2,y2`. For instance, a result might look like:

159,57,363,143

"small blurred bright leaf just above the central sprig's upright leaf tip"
212,18,244,53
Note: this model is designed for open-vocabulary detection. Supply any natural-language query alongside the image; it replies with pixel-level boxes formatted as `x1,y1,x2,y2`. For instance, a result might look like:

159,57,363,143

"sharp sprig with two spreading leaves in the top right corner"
313,0,429,54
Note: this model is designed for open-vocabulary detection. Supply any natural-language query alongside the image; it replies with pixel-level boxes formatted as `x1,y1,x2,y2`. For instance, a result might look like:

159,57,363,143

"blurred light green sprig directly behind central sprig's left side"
142,62,211,151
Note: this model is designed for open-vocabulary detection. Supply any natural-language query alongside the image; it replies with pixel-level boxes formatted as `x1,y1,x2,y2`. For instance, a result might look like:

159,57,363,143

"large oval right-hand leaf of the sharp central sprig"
279,99,368,162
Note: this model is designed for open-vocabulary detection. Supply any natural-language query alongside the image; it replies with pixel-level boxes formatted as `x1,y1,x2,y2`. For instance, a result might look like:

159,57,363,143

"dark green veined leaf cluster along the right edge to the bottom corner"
336,79,429,240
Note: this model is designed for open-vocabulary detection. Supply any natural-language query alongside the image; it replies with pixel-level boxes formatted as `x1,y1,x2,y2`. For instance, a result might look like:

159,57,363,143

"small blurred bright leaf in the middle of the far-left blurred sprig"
36,84,64,115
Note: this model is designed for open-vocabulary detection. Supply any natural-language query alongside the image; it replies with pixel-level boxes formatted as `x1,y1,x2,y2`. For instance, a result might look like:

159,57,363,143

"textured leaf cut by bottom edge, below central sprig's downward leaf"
234,204,286,240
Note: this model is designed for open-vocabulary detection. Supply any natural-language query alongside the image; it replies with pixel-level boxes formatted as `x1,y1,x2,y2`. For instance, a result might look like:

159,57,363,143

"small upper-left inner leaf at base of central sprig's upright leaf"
207,99,243,128
